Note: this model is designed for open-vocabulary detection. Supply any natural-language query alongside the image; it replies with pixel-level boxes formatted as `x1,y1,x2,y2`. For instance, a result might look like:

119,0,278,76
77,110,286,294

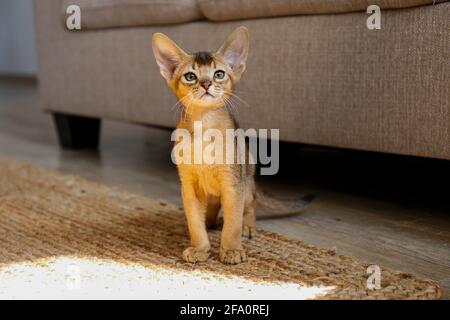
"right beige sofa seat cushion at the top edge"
198,0,439,21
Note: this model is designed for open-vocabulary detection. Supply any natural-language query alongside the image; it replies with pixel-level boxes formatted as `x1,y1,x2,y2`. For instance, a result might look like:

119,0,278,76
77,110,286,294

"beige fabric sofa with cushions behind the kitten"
35,0,450,159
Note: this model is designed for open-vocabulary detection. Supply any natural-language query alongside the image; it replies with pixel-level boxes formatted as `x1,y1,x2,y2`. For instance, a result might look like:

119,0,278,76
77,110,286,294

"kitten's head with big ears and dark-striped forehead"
152,27,249,108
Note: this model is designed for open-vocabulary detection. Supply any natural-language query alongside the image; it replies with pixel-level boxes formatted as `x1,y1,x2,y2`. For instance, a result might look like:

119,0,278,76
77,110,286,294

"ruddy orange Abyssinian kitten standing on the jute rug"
152,27,312,264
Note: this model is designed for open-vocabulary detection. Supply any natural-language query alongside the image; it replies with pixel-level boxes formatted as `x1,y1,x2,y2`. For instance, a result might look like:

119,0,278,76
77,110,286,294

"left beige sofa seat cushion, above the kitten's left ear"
62,0,203,30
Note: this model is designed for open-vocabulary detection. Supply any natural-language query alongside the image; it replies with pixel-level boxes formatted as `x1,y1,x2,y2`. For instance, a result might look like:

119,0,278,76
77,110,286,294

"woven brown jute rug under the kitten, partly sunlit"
0,157,441,299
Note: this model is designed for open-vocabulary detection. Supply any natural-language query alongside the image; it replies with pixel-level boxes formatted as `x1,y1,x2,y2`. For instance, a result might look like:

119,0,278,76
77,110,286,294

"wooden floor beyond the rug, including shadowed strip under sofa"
0,78,450,298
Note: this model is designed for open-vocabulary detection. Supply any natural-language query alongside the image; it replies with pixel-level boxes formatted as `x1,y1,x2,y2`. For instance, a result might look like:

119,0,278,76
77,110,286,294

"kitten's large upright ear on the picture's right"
218,27,249,77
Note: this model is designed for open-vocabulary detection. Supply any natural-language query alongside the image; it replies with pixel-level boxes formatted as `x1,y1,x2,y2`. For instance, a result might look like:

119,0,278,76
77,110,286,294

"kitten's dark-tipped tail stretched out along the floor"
256,187,315,220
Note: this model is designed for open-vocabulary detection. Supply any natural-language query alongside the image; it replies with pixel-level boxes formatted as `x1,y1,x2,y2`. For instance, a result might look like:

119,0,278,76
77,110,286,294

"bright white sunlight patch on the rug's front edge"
0,257,335,300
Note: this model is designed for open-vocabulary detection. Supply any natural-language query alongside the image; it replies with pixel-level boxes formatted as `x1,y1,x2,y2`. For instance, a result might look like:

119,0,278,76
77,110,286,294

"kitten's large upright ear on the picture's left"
152,33,187,80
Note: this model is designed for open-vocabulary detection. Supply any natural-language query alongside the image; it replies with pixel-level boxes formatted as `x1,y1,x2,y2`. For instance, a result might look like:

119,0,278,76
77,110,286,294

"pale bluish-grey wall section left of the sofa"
0,0,39,75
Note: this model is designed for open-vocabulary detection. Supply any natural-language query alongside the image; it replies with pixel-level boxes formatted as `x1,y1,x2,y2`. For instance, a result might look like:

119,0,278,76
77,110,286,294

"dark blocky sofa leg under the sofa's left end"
53,113,101,150
